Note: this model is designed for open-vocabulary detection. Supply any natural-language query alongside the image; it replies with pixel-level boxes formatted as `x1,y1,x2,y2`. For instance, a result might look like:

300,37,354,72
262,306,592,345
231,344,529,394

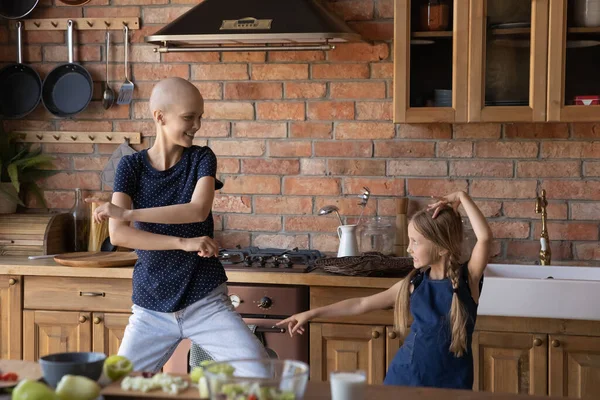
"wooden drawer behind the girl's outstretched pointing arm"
310,287,394,325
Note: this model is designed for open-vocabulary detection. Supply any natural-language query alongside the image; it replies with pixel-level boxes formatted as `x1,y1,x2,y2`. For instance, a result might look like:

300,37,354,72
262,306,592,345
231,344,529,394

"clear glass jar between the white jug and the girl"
358,217,396,255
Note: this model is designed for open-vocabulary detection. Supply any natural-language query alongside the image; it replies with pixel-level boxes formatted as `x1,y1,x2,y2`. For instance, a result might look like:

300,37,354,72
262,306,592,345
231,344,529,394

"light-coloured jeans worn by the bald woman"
119,284,268,372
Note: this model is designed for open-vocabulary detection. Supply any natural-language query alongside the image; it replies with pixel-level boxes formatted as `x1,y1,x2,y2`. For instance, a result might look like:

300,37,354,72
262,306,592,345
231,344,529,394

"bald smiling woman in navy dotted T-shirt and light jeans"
89,78,267,372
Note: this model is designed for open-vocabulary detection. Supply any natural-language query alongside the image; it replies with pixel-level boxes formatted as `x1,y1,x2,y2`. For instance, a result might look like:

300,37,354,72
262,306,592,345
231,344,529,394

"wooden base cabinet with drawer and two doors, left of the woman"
23,276,131,360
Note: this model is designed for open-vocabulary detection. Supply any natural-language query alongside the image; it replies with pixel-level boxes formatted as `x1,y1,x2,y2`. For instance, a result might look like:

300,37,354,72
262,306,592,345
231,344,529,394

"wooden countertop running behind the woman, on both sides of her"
0,256,398,289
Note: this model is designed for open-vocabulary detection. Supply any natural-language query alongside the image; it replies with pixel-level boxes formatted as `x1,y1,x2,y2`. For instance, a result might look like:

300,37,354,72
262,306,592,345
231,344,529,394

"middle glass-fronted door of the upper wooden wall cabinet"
468,0,549,122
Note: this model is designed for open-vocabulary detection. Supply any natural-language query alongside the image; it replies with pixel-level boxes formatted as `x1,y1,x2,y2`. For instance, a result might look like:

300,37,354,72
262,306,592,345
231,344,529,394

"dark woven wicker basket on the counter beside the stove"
315,253,413,278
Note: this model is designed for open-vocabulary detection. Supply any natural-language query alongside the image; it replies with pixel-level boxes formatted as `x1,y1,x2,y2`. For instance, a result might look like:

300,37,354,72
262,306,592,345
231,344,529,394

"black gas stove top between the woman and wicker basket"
219,246,324,273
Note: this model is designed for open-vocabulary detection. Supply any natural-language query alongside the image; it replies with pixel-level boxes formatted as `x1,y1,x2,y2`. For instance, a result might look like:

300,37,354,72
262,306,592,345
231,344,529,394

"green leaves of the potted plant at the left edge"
0,121,58,214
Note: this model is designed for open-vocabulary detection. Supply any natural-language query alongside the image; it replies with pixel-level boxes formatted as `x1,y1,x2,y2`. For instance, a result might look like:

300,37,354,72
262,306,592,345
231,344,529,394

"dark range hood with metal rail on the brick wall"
146,0,361,53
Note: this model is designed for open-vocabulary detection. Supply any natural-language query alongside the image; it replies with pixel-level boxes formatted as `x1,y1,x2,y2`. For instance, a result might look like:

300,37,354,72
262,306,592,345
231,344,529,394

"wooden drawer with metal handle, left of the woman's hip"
23,276,132,312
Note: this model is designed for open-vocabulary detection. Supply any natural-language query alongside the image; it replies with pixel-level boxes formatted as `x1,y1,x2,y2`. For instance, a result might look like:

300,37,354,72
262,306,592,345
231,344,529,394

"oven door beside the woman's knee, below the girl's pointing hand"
244,318,308,363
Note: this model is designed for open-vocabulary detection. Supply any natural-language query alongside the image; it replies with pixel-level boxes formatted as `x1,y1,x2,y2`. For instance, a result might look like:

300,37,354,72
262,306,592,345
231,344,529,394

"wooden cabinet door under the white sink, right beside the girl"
472,332,548,395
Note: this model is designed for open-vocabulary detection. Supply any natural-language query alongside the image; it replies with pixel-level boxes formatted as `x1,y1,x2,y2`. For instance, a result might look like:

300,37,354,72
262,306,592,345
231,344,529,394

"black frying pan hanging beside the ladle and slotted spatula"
42,20,94,118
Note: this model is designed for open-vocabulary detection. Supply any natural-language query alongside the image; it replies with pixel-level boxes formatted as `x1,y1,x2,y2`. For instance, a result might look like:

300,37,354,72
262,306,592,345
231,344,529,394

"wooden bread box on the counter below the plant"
0,213,72,256
